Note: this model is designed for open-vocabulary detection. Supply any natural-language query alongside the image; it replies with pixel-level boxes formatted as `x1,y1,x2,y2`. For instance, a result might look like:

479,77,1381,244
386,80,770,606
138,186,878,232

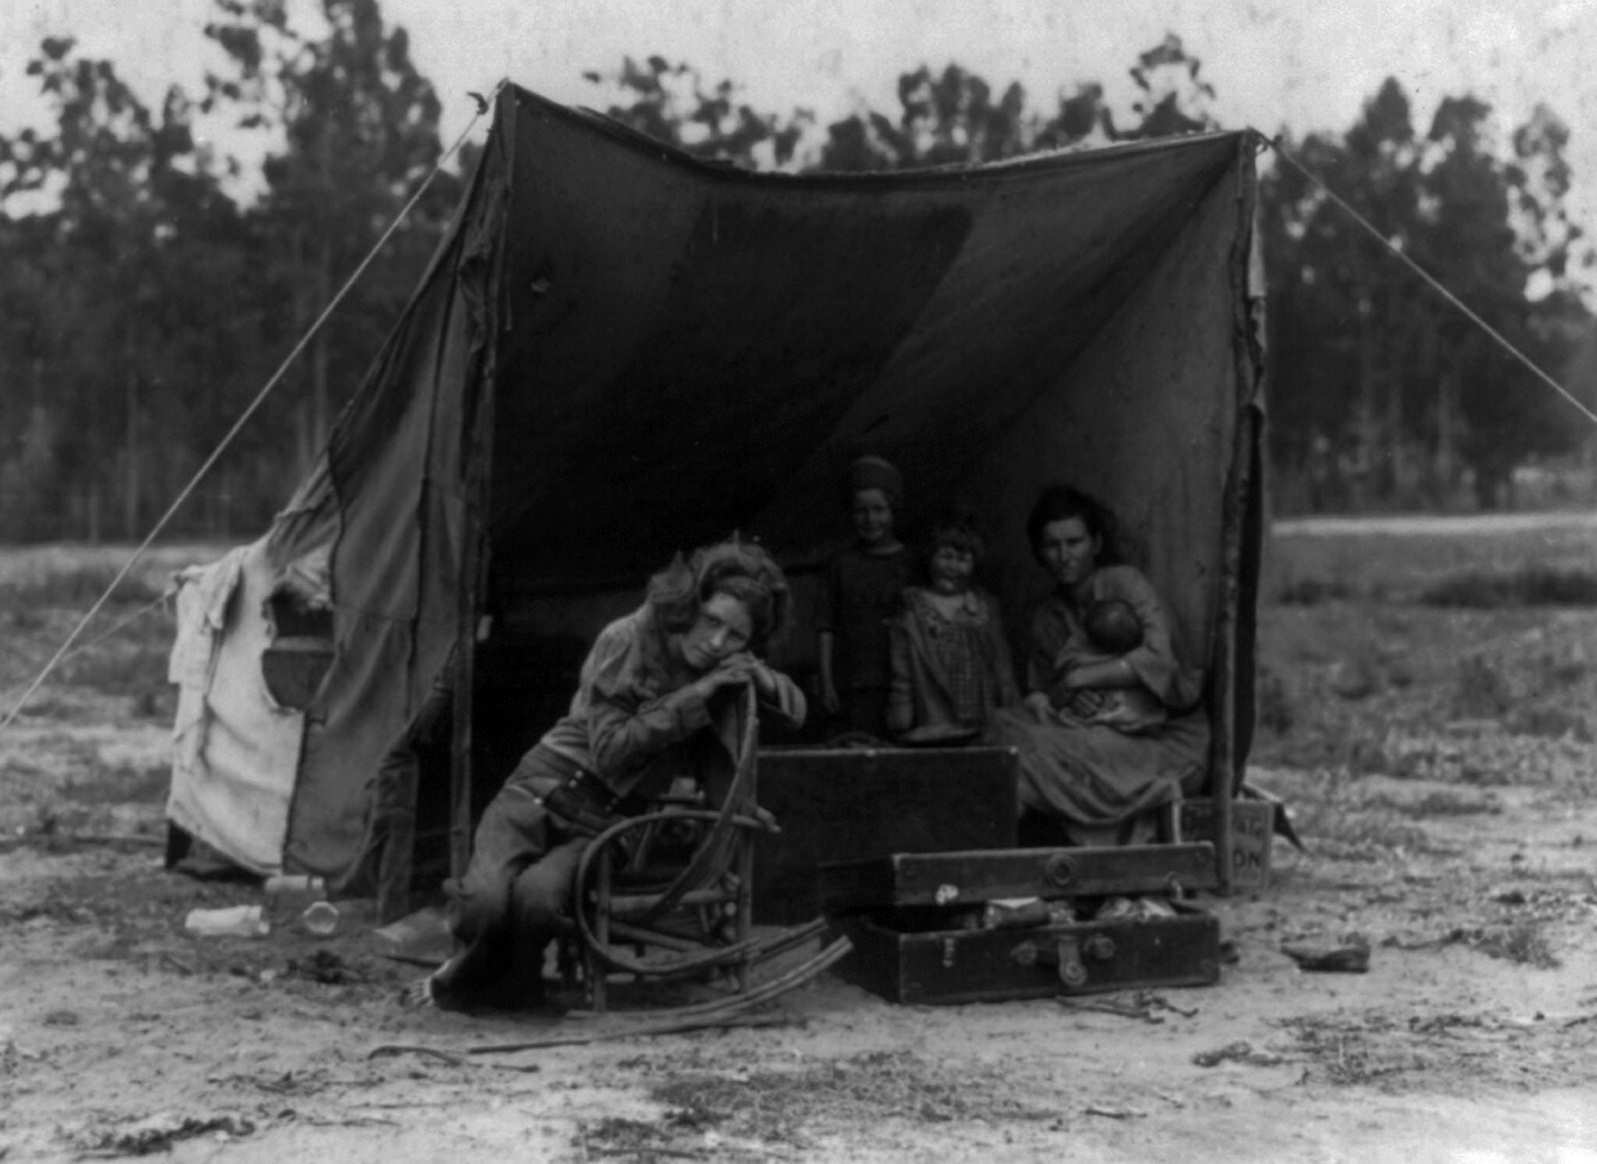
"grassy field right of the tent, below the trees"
1254,514,1597,781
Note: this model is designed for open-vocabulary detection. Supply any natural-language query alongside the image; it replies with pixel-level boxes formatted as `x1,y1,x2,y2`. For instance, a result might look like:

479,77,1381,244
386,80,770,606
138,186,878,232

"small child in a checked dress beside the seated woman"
886,517,1020,744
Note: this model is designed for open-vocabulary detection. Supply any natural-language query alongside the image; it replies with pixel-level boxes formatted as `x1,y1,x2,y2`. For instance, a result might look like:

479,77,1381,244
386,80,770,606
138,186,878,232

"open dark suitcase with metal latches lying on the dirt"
819,843,1220,1003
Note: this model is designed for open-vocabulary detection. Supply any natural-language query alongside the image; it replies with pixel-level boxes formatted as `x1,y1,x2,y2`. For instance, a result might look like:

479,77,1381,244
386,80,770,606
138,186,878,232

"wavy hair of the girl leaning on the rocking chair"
647,538,792,653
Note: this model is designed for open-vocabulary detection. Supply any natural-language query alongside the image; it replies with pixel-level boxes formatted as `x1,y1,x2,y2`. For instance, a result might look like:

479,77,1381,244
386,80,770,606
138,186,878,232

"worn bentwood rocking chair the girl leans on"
572,688,819,1012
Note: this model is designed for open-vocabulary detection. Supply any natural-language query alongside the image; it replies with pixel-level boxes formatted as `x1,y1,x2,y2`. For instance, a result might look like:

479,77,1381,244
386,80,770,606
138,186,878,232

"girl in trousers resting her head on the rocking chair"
407,541,805,1009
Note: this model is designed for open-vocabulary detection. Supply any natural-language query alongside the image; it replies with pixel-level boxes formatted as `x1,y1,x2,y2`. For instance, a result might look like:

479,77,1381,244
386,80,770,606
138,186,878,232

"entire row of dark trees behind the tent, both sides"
0,0,1592,540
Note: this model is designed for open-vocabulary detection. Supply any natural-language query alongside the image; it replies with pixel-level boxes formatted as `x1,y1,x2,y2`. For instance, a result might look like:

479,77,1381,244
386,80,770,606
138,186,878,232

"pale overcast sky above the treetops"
0,0,1597,232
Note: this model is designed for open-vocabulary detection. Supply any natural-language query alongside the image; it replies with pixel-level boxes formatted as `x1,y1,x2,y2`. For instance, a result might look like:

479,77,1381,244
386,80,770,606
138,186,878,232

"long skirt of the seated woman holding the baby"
993,709,1209,827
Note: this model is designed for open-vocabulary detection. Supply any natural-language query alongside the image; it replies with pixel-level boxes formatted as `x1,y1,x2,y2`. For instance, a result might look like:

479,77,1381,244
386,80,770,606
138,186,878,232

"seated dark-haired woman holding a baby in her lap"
995,485,1209,843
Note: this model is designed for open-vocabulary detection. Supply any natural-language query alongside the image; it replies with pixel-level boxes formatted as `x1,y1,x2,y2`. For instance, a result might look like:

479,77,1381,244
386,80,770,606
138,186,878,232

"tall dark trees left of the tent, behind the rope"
0,0,463,540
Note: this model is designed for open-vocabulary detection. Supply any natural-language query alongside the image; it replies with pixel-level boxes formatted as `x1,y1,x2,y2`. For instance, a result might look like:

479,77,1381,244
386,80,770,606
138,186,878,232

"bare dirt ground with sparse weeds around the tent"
0,530,1597,1164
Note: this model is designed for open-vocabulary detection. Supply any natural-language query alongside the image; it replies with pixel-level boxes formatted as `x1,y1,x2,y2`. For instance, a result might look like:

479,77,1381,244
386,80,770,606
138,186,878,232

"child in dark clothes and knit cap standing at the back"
818,457,909,736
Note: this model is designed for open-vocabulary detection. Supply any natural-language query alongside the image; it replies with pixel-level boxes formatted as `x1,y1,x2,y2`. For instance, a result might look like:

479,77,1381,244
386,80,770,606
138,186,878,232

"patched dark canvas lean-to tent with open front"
171,86,1262,913
